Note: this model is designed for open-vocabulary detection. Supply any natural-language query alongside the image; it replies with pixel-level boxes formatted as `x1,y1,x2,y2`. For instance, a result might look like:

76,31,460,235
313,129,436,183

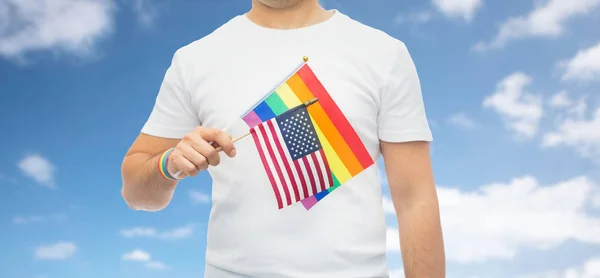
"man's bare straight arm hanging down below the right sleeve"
381,142,446,278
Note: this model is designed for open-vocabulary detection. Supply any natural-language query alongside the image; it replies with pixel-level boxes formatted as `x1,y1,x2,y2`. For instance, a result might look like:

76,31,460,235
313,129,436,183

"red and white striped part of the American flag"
250,118,333,209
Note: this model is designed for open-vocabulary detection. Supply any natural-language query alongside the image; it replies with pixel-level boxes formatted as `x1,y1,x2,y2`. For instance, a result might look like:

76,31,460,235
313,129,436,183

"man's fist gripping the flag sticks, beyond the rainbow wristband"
167,127,236,178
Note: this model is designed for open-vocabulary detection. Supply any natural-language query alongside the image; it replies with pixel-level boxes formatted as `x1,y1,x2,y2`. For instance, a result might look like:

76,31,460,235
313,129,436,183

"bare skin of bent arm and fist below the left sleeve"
121,127,235,211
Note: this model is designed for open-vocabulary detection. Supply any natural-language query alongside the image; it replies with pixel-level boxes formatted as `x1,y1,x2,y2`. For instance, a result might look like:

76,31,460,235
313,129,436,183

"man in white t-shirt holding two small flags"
122,0,445,278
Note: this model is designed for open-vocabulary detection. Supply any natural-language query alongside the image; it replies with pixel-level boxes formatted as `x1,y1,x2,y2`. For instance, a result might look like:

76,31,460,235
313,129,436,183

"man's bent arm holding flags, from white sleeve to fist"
121,48,235,211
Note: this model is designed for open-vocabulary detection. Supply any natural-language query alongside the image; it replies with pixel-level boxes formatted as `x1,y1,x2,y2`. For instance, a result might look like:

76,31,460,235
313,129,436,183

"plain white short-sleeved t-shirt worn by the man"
142,11,432,278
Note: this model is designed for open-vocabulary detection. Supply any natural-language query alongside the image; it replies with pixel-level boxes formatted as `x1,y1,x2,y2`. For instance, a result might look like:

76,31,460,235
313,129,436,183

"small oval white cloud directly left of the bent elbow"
18,154,56,188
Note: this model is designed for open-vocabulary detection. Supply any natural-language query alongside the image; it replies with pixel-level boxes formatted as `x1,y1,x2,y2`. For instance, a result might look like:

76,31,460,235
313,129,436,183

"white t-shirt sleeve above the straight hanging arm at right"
377,42,433,142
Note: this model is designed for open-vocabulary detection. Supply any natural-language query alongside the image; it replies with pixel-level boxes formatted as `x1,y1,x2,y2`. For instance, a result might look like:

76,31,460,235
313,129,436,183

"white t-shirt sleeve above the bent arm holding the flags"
142,51,200,139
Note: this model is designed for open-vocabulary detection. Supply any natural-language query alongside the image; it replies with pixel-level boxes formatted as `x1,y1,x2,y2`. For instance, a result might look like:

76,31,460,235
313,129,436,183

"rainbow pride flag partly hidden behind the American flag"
242,63,374,210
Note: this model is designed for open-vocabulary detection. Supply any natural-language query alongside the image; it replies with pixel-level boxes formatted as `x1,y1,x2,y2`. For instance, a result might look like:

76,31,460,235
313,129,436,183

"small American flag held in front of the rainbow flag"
250,104,333,209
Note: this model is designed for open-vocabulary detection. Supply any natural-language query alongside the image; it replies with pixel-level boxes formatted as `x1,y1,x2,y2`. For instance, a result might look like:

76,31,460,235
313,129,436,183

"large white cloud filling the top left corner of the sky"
0,0,115,61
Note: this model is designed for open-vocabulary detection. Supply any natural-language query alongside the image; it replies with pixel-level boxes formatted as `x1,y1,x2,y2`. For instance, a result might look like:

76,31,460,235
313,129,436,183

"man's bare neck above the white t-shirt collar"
246,0,333,30
